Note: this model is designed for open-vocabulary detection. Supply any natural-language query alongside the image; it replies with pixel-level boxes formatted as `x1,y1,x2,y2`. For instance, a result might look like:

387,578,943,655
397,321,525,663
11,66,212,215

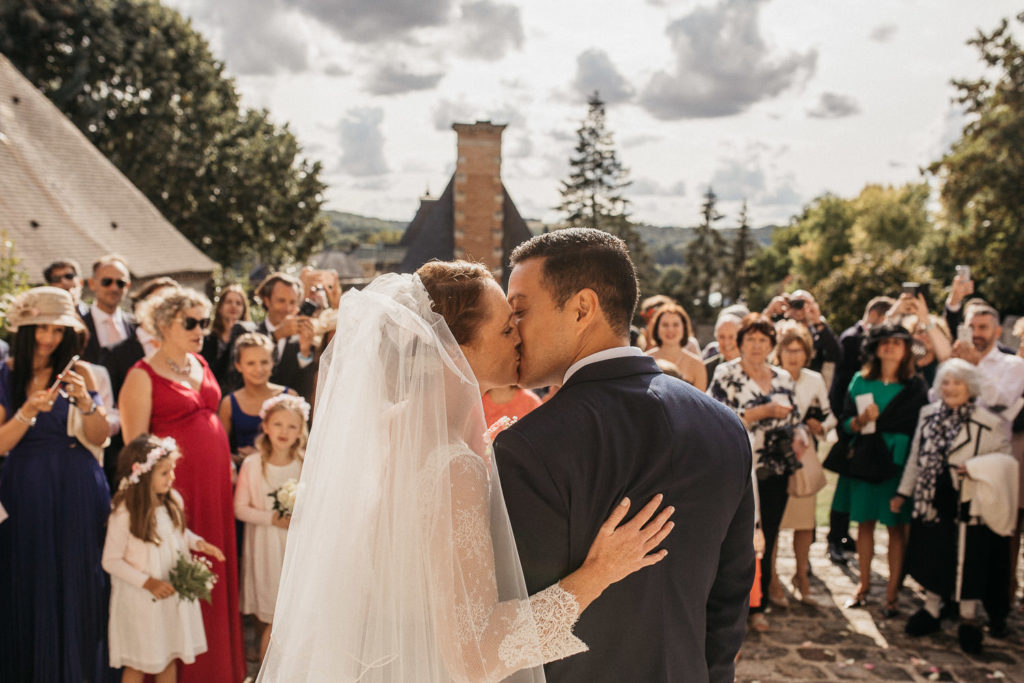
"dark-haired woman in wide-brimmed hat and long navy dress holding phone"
0,287,111,681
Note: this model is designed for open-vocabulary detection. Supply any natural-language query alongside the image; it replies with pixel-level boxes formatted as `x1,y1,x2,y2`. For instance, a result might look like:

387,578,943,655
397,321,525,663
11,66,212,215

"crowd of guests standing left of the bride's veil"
0,255,331,683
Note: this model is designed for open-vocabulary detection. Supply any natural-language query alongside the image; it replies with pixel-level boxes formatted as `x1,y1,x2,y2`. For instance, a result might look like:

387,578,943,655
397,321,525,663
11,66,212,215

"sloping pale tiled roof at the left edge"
0,54,216,283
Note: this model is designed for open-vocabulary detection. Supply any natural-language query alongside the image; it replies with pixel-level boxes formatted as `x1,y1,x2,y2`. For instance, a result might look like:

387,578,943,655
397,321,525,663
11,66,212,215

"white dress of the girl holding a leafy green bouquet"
102,499,207,674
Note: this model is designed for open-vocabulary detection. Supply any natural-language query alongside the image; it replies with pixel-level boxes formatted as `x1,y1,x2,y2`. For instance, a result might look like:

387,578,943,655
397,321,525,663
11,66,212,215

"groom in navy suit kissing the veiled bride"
495,228,754,683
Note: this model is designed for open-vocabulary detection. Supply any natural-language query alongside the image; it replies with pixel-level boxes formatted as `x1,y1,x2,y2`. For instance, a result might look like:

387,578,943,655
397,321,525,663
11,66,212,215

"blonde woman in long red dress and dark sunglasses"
118,289,246,683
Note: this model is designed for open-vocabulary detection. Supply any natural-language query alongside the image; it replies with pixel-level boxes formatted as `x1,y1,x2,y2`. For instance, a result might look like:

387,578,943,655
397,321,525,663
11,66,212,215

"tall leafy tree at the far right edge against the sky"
927,12,1024,311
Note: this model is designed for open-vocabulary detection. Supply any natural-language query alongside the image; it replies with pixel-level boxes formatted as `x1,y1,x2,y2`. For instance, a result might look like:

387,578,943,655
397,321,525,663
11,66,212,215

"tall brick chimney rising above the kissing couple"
452,121,505,278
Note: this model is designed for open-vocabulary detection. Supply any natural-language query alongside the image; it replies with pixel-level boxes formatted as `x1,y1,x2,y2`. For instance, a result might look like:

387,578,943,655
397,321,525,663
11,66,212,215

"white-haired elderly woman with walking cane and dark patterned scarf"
890,358,1016,653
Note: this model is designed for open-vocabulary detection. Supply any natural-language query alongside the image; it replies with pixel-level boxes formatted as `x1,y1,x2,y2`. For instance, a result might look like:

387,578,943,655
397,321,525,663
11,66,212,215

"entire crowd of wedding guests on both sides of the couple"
0,250,1024,683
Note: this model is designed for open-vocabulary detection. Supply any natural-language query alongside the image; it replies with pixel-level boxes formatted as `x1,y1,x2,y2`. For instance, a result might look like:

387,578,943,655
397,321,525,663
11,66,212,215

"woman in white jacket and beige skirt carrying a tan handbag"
768,322,838,605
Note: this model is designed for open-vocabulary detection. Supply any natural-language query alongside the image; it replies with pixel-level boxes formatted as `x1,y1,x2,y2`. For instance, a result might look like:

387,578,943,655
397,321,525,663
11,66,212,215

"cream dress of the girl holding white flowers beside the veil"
234,453,302,624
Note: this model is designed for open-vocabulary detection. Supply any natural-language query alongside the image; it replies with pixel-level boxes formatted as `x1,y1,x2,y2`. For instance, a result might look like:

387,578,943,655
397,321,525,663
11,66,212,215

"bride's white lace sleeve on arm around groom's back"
433,454,587,681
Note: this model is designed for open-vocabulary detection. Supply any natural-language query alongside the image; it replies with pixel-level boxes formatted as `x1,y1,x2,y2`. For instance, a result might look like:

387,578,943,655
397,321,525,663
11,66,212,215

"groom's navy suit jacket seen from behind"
495,356,754,683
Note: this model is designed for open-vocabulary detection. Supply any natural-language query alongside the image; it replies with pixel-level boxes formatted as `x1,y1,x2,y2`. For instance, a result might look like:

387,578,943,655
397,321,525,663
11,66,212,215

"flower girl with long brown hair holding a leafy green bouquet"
102,434,224,683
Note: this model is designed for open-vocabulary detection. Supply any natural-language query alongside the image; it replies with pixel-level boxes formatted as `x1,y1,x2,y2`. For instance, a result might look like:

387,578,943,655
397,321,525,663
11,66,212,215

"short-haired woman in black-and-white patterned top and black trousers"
708,313,800,631
